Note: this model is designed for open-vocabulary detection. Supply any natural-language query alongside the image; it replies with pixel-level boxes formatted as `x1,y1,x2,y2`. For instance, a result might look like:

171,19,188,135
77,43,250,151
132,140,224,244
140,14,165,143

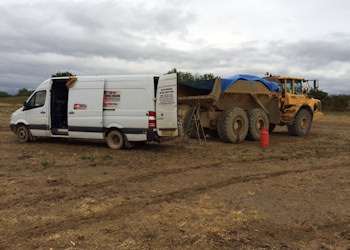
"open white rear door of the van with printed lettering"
156,74,178,136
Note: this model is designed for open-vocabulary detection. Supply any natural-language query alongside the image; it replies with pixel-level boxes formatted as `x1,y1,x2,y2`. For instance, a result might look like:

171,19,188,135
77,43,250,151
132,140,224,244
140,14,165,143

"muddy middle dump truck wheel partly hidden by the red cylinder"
247,109,269,141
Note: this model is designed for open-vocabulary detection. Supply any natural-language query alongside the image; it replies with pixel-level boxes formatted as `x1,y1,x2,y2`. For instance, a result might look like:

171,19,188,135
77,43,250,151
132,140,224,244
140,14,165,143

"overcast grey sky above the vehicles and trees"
0,0,350,94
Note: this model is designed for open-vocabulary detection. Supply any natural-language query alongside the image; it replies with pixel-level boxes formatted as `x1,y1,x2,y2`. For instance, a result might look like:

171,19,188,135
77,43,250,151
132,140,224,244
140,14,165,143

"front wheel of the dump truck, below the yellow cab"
287,109,312,136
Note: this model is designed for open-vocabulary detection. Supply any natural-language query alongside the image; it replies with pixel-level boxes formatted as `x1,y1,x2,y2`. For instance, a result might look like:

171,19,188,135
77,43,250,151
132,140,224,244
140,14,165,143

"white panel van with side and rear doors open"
10,74,178,149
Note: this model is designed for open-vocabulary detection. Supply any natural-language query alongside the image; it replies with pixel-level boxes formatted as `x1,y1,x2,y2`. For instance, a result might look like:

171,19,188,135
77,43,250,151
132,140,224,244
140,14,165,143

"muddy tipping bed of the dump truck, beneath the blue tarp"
178,78,280,123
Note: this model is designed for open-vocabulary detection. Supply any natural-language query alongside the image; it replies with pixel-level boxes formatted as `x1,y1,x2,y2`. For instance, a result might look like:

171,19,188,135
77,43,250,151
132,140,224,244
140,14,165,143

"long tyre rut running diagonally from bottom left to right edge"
6,160,348,244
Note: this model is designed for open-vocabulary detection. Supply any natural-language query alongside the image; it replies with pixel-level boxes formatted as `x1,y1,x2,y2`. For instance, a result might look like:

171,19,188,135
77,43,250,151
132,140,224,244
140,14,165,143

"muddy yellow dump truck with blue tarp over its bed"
178,75,323,143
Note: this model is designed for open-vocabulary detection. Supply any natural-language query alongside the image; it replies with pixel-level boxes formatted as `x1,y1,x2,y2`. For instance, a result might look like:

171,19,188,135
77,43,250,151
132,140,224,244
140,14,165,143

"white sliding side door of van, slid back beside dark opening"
68,80,104,139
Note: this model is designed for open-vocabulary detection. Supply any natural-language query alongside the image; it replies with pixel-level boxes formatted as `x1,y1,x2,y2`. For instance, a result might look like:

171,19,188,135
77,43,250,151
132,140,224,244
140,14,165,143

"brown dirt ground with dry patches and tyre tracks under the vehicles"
0,104,350,249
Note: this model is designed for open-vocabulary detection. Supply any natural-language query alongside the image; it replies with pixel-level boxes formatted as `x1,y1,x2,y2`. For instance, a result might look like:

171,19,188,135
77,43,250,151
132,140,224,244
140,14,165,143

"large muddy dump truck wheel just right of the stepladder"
217,108,249,143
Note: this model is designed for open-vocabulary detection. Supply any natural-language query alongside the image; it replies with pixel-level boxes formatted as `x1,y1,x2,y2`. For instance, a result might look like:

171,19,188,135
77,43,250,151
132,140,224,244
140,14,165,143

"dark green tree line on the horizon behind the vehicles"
0,71,350,112
